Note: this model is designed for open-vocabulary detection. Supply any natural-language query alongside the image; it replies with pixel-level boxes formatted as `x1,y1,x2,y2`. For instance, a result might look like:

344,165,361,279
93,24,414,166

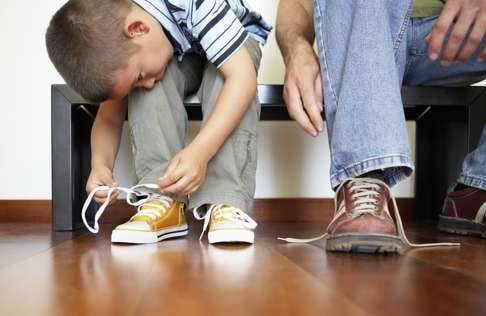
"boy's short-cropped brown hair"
46,0,138,102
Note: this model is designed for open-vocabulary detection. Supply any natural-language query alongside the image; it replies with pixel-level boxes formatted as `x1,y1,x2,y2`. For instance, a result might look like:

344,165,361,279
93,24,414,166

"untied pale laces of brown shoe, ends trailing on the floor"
277,178,460,248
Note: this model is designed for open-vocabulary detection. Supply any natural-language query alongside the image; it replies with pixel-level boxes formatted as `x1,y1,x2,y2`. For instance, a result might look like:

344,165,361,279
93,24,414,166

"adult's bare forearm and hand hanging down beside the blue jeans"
276,0,324,136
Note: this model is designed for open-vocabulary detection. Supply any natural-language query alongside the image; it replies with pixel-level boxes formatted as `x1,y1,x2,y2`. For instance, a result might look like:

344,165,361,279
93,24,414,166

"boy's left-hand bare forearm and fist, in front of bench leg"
86,99,127,203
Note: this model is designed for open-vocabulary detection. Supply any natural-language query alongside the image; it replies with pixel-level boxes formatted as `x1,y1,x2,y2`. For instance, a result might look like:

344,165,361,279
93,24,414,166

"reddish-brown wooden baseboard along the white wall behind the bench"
0,198,416,223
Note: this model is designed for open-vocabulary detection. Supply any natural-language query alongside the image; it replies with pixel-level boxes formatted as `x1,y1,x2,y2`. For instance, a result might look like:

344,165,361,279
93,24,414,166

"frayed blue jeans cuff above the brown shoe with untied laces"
331,154,414,190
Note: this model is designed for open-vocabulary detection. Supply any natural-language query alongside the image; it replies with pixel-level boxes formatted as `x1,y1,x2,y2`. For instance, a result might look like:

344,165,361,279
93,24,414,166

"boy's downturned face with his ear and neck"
110,5,174,100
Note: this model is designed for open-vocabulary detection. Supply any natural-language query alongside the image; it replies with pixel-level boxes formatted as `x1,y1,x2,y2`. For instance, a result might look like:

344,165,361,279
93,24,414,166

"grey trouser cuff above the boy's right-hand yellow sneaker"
188,192,253,213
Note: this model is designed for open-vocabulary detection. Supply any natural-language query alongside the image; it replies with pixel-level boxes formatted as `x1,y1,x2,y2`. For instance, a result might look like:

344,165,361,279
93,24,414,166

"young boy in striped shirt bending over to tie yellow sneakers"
46,0,271,243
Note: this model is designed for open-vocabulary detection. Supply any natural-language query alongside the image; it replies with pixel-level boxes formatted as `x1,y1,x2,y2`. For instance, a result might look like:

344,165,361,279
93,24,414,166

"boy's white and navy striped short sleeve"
191,0,248,68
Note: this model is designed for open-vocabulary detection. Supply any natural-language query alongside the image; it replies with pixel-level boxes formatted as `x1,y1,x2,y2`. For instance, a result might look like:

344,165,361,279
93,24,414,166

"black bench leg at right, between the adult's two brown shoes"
416,93,486,221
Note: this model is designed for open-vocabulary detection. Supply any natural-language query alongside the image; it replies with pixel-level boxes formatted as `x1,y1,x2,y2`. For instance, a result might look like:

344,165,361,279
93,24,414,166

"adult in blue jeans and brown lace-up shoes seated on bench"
277,0,486,252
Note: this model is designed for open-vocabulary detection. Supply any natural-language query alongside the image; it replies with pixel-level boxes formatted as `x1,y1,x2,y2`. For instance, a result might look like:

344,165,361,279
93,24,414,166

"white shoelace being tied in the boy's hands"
81,184,173,234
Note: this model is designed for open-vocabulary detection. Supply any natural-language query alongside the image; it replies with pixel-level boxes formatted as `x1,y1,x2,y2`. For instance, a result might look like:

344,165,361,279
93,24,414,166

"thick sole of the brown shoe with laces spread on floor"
326,234,404,254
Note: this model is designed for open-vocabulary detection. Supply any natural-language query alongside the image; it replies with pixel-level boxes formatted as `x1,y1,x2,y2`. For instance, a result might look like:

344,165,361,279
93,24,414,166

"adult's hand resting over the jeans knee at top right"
427,0,486,66
